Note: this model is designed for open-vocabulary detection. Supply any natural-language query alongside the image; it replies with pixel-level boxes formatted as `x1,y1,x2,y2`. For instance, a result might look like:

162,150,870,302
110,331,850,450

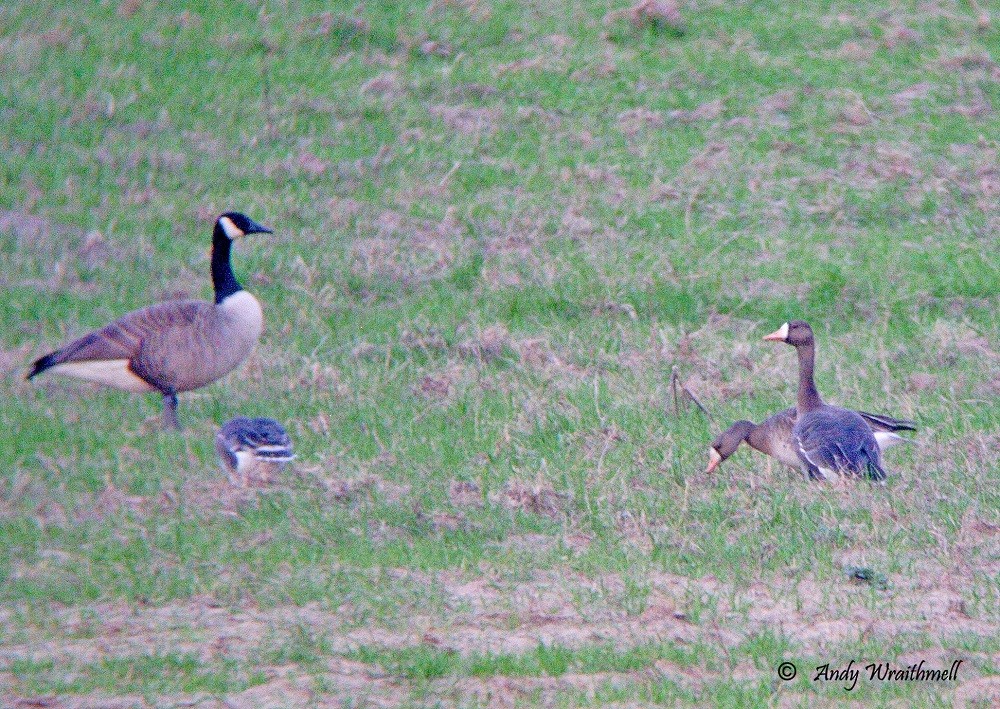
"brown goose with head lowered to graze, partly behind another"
705,407,917,473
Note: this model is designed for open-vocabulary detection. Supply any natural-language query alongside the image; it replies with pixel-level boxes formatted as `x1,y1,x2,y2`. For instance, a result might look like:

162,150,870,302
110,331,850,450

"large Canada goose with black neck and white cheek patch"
27,212,273,429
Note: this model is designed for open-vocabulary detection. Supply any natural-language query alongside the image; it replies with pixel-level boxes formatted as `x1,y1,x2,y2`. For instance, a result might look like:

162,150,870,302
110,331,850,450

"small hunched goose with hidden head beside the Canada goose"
215,416,295,487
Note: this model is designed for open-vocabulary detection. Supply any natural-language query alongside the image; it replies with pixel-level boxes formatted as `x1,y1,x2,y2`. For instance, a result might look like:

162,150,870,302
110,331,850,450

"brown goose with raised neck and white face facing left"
764,320,885,481
